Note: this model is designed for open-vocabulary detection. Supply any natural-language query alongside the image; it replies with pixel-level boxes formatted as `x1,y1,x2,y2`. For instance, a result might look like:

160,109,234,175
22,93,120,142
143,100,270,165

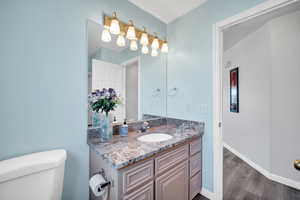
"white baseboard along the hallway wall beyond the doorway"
223,142,300,190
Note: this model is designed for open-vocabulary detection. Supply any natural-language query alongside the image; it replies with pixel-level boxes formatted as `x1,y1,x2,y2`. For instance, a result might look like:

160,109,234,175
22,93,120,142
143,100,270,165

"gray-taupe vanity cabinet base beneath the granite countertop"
90,138,202,200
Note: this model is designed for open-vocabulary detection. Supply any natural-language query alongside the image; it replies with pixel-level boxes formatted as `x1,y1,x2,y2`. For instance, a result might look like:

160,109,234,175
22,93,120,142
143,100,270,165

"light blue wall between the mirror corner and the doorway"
167,0,264,191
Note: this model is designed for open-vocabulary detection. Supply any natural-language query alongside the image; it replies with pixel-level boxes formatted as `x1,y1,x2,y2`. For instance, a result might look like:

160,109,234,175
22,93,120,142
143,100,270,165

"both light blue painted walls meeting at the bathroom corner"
0,0,272,200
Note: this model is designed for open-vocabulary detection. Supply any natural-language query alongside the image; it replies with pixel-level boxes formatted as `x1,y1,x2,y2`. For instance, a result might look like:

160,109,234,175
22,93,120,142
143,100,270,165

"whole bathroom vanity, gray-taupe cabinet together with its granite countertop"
88,119,204,200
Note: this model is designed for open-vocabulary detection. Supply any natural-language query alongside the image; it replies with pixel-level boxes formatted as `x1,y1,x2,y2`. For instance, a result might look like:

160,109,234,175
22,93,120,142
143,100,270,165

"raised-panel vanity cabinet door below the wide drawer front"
155,161,189,200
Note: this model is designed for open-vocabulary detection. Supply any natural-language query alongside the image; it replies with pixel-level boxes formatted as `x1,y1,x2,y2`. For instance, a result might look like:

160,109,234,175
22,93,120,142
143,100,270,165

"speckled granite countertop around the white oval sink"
88,123,204,169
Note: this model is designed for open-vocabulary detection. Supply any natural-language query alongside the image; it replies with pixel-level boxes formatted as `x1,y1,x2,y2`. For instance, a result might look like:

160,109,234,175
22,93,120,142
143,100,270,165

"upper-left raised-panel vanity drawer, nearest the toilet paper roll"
122,160,154,194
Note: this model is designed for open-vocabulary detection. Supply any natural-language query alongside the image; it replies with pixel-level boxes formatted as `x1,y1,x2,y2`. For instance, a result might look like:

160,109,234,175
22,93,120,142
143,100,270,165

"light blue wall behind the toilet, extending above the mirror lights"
0,0,166,200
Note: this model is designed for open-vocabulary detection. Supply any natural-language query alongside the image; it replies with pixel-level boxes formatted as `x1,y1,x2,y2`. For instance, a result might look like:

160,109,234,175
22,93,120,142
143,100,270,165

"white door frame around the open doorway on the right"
211,0,299,200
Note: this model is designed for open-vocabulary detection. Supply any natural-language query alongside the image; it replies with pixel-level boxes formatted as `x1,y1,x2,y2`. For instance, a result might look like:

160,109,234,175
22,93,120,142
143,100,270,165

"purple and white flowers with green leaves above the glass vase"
89,88,122,116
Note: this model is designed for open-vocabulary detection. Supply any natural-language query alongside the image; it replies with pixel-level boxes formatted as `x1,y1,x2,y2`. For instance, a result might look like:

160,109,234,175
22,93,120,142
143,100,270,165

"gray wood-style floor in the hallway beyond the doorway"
223,148,300,200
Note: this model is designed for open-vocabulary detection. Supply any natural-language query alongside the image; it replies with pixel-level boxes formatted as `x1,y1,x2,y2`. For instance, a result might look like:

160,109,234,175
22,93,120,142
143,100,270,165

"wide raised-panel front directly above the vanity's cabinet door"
155,145,188,174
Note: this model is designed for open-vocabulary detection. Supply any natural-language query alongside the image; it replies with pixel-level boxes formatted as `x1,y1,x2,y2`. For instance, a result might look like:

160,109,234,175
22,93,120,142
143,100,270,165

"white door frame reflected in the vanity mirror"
121,56,142,120
